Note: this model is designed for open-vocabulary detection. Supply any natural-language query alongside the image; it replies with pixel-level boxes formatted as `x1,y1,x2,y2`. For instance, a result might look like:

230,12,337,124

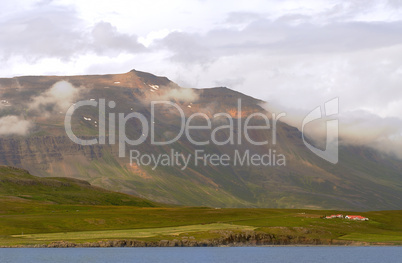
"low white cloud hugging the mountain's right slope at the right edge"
261,103,402,159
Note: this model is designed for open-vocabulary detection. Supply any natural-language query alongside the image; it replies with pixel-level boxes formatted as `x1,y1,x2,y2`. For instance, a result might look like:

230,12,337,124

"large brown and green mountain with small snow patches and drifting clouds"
0,70,402,210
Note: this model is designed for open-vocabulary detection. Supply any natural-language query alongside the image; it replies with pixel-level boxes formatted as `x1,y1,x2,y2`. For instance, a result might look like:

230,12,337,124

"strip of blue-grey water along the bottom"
0,247,402,263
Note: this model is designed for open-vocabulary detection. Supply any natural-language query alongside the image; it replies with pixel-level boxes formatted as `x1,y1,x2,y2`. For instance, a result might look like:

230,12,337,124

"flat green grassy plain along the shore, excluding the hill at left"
0,200,402,246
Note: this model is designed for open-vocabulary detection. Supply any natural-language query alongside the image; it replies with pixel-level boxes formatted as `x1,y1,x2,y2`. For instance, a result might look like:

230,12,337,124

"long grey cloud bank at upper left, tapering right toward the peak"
0,6,145,64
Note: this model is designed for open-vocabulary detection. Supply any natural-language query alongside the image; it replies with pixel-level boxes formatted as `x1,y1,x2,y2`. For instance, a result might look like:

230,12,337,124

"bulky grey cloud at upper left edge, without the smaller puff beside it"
0,4,83,60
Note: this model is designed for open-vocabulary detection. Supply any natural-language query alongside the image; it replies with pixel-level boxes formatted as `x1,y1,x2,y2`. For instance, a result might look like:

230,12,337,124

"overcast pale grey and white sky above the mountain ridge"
0,0,402,156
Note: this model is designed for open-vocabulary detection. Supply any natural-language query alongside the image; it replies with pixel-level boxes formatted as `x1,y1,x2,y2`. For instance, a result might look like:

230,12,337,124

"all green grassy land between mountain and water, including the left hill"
0,166,402,246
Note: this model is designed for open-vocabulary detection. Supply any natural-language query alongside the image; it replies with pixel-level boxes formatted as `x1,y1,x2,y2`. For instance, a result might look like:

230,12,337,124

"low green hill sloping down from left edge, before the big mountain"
0,166,157,207
